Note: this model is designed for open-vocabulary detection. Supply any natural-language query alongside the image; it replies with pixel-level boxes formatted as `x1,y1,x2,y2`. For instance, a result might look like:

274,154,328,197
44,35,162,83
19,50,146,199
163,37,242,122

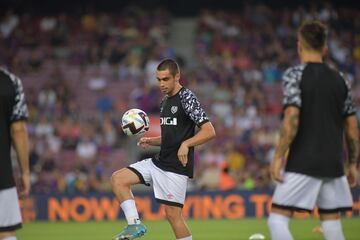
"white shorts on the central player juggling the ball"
128,158,188,207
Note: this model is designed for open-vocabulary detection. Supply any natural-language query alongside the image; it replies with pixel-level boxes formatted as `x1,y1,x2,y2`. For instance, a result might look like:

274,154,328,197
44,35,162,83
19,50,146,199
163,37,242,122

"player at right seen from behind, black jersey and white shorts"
268,21,359,240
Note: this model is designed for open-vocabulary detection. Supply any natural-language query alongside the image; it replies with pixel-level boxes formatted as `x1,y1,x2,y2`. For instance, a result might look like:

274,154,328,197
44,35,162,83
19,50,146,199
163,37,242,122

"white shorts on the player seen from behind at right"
272,172,353,213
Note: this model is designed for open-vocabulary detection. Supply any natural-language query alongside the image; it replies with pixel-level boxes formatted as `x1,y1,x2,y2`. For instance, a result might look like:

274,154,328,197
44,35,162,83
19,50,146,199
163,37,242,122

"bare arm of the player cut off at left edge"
11,121,30,195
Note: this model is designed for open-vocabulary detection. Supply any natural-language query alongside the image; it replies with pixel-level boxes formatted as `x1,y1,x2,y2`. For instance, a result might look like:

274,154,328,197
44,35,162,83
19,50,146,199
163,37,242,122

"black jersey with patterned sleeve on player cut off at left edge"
0,68,28,190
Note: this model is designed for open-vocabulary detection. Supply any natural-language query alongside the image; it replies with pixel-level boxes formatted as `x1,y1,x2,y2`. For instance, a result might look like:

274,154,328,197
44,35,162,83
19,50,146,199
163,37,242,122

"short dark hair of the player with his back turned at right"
298,20,328,52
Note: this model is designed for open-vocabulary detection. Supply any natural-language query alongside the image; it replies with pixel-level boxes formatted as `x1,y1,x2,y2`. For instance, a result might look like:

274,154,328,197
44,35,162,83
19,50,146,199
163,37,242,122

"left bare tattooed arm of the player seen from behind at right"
270,106,300,182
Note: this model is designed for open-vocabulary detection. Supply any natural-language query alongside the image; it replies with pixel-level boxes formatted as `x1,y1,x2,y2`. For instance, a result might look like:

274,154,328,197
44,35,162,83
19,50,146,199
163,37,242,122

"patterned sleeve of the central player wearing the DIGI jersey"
180,89,209,126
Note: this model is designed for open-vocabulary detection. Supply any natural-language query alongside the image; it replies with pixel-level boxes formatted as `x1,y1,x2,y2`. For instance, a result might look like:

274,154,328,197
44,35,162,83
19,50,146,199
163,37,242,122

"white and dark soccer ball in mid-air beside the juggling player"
121,108,150,136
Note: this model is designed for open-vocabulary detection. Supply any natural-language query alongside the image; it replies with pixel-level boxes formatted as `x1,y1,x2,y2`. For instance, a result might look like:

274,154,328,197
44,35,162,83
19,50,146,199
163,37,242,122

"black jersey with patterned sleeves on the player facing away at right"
283,63,356,177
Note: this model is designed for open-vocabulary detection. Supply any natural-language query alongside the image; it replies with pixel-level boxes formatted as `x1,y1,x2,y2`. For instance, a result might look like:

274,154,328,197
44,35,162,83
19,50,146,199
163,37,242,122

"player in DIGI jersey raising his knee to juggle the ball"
111,59,215,240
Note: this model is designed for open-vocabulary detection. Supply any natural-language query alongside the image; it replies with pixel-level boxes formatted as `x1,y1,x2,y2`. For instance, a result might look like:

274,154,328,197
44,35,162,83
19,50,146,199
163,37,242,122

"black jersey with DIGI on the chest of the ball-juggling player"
153,87,209,177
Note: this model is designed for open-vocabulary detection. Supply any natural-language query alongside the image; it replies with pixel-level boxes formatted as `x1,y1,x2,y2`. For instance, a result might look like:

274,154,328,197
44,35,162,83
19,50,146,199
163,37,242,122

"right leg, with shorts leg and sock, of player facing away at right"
317,176,353,240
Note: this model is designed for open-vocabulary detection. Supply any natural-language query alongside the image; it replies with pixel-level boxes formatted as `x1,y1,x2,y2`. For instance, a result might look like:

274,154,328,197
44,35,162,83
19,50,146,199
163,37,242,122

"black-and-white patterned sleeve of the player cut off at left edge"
10,74,29,122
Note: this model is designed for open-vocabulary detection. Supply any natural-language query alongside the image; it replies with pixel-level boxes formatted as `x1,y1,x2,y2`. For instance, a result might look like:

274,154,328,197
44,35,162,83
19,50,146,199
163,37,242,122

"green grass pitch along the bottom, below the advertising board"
18,218,360,240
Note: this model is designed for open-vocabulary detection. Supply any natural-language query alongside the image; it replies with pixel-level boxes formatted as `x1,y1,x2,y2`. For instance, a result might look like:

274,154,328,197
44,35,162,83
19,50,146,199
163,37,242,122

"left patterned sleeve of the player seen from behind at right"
282,65,304,109
